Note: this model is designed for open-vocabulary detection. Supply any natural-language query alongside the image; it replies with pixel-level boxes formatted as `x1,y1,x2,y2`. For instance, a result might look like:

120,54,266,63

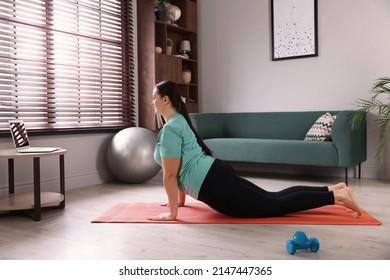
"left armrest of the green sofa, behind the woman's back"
190,113,223,139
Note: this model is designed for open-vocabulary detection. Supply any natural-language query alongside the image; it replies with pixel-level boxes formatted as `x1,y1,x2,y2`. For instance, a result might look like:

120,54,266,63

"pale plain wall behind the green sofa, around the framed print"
198,0,390,179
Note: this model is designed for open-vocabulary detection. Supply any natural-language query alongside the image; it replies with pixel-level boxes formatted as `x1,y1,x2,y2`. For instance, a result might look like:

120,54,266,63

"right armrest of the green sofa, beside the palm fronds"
332,111,367,167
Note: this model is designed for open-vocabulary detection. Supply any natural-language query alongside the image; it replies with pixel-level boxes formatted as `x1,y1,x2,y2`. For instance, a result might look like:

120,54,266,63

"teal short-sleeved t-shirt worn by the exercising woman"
154,113,215,199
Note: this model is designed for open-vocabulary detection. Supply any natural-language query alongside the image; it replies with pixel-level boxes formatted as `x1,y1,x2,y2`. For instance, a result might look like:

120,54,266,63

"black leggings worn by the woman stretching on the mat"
198,159,334,218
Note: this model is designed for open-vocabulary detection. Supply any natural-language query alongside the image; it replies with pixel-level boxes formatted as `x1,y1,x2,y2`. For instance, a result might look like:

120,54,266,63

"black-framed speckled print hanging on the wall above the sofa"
271,0,318,61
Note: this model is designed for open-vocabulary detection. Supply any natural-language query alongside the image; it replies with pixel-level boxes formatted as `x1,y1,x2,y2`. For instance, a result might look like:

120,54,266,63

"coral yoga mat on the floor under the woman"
92,203,382,225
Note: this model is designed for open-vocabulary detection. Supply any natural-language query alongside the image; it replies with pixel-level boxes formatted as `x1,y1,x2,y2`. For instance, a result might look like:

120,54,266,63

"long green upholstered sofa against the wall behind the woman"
190,111,367,183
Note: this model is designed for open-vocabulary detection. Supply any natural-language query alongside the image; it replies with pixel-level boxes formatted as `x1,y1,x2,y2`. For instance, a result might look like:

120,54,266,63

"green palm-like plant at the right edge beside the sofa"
350,77,390,166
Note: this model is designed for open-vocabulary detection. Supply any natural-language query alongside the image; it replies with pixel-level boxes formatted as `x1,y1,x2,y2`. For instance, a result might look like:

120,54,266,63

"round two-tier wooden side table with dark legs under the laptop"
0,149,66,221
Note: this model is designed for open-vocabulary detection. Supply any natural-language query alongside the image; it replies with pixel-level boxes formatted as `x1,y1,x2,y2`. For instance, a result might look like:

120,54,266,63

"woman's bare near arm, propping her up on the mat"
148,158,184,221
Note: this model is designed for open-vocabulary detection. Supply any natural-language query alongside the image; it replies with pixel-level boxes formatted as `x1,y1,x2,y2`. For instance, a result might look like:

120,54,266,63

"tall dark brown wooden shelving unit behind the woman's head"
137,0,199,130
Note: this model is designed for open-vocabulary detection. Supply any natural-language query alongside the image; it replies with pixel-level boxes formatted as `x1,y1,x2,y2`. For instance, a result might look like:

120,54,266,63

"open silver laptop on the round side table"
8,120,60,153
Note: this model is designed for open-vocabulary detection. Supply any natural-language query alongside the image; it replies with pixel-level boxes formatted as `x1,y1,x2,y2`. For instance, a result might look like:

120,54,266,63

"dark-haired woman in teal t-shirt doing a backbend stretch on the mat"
148,81,362,221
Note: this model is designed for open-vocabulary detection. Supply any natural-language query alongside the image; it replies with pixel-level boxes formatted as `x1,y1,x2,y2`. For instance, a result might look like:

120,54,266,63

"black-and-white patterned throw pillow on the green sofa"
305,113,336,141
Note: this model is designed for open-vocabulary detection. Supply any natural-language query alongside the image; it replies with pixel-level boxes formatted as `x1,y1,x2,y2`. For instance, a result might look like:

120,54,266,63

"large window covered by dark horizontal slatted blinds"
0,0,135,131
